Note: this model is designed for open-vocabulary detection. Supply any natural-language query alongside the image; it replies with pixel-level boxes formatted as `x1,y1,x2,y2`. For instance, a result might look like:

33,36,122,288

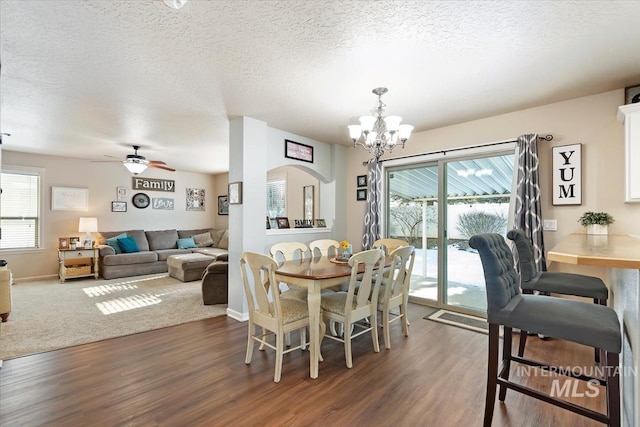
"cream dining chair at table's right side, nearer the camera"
320,249,385,368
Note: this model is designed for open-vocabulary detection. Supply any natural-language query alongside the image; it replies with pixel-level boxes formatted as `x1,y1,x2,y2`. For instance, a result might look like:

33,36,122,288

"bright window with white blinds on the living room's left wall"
0,168,41,249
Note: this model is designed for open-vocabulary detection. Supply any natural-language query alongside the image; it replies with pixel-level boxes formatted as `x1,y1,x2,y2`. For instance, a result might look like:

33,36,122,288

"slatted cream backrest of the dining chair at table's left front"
240,252,282,320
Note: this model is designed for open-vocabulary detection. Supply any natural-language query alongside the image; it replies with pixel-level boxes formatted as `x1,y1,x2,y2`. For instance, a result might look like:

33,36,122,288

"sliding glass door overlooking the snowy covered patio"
385,151,514,313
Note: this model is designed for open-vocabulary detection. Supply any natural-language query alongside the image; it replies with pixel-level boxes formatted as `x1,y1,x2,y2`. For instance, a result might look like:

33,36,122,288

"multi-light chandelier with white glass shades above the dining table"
348,87,413,160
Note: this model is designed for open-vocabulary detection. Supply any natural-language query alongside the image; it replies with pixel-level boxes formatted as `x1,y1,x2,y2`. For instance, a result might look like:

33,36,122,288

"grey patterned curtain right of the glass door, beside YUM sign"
513,134,547,271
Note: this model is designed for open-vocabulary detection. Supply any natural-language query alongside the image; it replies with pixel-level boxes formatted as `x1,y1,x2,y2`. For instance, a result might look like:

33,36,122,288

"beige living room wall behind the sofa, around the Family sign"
2,150,218,280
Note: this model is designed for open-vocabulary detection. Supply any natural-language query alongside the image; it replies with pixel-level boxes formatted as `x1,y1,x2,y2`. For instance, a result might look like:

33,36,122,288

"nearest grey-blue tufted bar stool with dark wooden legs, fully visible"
469,234,622,427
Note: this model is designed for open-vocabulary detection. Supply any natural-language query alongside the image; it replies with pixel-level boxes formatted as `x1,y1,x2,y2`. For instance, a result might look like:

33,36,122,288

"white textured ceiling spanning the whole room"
0,0,640,173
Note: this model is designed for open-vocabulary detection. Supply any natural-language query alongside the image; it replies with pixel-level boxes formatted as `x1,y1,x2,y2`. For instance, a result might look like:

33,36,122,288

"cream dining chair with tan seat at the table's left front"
240,252,324,383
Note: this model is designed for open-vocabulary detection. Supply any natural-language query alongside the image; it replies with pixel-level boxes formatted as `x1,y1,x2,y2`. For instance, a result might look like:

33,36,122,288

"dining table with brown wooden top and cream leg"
275,256,364,379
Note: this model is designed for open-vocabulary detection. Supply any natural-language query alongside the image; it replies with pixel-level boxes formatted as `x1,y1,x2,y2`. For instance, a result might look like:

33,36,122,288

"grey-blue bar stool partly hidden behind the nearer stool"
507,229,609,362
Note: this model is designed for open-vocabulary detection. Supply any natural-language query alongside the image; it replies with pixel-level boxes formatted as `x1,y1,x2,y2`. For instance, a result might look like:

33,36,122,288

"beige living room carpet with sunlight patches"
0,273,227,360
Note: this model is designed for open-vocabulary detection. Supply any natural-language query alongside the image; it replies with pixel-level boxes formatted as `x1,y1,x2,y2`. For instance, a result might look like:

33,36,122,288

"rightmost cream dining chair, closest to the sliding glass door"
378,246,416,348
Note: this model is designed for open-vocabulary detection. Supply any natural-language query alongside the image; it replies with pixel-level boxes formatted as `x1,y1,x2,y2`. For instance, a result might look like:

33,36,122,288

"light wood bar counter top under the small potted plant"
547,234,640,270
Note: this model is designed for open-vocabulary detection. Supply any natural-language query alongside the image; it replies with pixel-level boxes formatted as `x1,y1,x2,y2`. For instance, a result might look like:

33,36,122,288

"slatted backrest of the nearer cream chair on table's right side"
346,249,385,312
